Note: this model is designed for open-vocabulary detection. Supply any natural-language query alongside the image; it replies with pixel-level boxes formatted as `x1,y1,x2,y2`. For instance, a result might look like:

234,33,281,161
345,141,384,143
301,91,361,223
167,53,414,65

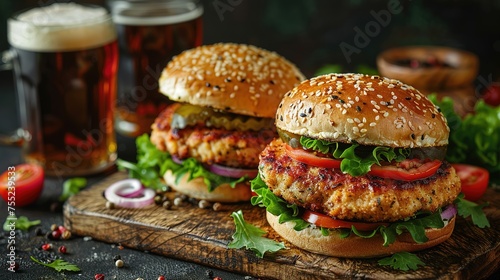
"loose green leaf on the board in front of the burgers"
228,210,285,258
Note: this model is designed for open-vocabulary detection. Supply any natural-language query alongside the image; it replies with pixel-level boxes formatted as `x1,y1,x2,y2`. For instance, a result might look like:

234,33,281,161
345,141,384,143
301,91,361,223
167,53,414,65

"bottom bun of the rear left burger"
163,170,252,203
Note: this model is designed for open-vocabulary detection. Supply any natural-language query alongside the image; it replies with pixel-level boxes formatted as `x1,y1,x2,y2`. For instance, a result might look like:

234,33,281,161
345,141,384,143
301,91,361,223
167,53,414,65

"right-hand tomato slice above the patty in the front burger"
368,159,441,181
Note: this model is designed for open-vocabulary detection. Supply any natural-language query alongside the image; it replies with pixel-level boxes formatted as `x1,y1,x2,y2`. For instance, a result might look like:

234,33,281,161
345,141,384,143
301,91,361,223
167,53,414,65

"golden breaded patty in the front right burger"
259,139,461,222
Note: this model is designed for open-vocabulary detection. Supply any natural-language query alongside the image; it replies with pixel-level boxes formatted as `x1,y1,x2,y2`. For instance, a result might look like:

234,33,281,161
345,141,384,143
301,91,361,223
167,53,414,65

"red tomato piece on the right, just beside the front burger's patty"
452,163,490,201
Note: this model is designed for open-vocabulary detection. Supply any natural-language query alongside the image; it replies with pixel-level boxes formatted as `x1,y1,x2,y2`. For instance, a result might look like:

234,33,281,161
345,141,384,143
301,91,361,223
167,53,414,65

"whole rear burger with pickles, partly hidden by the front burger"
150,43,305,202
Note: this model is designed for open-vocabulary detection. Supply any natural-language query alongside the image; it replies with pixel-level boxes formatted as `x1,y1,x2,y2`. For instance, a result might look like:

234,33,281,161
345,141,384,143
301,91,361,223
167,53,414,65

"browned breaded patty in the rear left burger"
150,104,277,168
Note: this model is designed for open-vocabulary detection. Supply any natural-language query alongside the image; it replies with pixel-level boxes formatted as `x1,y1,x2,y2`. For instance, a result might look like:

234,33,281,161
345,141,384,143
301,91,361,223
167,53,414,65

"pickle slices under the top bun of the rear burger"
171,104,274,131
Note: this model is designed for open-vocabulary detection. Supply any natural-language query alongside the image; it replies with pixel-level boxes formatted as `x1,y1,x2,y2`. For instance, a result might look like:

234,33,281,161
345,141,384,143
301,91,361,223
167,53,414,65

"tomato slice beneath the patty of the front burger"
302,209,389,231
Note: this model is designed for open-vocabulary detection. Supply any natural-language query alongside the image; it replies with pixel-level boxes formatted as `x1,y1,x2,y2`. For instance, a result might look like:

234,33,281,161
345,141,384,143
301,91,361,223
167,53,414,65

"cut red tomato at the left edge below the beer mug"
0,163,45,207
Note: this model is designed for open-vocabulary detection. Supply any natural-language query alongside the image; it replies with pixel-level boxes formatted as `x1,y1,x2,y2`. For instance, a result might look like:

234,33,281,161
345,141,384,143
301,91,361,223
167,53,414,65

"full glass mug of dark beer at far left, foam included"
4,3,118,177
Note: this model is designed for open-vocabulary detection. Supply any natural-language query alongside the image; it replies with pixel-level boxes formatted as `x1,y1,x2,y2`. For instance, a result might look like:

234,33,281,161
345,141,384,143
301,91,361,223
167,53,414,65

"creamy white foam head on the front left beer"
8,3,117,51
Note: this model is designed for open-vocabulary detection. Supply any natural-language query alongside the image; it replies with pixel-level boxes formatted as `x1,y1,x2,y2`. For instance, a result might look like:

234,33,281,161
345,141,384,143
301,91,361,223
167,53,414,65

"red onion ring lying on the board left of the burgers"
104,179,156,208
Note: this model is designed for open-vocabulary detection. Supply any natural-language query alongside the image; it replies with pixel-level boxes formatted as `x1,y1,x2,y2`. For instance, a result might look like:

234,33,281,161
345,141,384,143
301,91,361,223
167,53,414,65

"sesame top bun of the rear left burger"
159,43,305,118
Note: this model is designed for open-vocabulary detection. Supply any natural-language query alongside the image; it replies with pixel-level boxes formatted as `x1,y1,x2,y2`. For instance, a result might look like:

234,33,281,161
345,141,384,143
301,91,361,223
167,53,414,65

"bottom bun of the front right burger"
266,212,455,258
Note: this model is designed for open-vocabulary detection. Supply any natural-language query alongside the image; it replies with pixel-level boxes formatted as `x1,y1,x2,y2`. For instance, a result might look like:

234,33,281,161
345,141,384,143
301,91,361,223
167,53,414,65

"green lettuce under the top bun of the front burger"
299,136,410,176
